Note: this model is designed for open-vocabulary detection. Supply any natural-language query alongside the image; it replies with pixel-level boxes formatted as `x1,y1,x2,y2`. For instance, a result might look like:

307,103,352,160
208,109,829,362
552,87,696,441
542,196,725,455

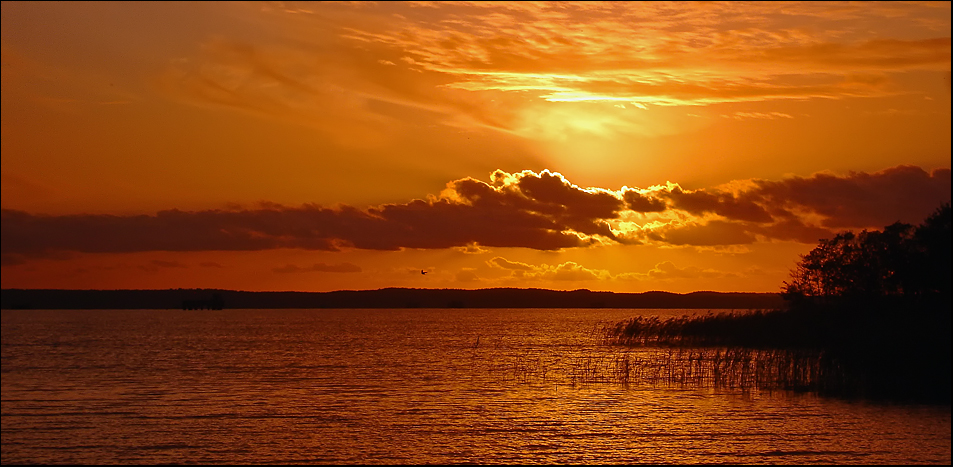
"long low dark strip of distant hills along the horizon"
0,288,784,310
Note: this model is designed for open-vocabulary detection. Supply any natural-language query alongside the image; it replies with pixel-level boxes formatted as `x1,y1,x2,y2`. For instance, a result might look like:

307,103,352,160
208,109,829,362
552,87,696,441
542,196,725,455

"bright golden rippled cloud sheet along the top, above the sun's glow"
326,2,950,105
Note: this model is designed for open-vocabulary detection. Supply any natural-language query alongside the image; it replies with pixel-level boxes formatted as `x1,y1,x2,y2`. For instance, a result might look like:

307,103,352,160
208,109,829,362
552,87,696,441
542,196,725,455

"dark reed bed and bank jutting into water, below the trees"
603,306,950,404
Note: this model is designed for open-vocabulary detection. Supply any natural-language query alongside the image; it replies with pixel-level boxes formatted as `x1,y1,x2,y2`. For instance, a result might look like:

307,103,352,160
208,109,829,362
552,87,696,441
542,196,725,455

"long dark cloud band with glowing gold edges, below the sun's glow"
0,166,950,265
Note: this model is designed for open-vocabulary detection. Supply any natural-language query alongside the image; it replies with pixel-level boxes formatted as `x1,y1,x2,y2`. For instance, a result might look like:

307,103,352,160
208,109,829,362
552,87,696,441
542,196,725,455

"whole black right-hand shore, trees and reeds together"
605,203,951,404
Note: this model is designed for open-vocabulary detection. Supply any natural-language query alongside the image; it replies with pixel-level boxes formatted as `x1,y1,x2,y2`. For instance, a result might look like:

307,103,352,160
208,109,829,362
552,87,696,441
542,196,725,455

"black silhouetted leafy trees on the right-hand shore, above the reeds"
782,203,950,303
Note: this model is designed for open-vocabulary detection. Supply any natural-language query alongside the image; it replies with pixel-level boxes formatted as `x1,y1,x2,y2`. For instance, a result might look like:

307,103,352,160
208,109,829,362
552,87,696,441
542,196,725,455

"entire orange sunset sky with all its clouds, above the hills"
0,1,951,292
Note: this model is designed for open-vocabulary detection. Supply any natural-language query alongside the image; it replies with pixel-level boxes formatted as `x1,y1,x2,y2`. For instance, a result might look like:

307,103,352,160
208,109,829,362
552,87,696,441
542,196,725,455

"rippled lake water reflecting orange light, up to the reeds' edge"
0,309,951,464
